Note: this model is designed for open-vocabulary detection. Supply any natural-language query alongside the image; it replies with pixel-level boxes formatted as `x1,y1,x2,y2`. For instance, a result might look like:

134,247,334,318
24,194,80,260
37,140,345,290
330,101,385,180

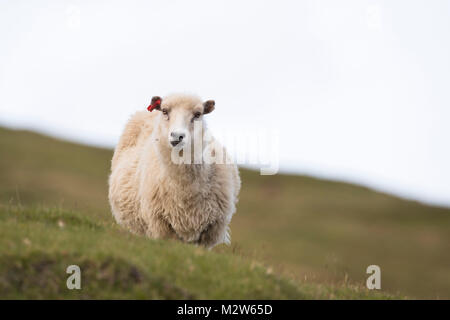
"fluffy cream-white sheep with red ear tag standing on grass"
109,94,241,248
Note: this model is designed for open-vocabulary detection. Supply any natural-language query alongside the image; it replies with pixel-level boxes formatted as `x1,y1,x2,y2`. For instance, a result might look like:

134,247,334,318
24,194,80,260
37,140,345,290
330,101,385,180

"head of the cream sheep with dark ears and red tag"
149,95,215,148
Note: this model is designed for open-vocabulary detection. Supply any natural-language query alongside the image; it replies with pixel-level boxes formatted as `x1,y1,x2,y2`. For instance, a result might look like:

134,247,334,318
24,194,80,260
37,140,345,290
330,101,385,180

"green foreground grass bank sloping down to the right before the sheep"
0,206,385,299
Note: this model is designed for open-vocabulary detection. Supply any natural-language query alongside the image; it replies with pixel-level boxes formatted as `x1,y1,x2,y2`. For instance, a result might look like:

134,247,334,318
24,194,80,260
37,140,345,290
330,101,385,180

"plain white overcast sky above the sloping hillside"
0,0,450,205
